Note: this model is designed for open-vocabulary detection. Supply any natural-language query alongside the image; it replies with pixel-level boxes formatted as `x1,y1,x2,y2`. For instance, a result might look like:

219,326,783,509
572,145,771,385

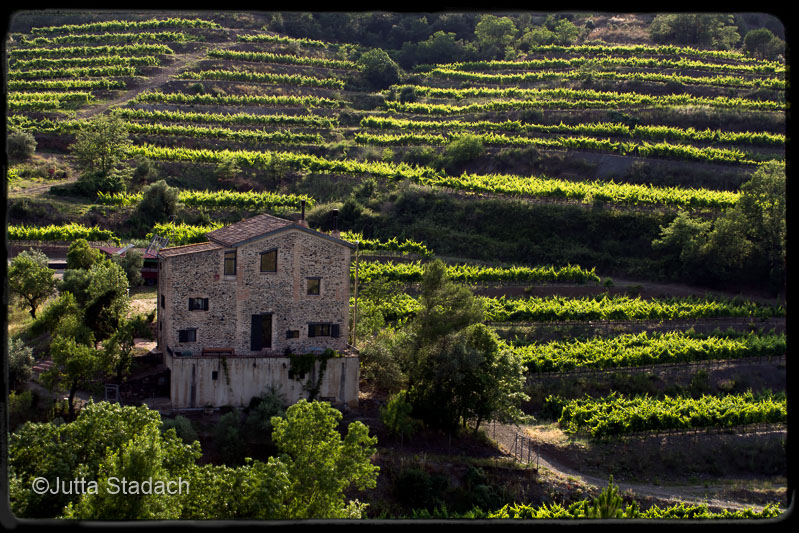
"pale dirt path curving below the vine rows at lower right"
486,424,784,511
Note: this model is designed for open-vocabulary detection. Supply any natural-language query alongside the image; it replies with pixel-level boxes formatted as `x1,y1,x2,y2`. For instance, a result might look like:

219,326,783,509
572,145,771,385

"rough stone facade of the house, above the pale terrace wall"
158,229,350,355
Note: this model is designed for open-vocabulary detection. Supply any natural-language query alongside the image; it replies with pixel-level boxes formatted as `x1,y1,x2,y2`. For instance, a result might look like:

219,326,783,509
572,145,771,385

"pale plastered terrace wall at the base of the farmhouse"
164,355,359,409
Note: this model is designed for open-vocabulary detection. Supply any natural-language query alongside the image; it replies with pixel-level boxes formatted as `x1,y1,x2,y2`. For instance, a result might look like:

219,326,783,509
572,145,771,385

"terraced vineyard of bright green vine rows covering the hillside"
6,13,788,520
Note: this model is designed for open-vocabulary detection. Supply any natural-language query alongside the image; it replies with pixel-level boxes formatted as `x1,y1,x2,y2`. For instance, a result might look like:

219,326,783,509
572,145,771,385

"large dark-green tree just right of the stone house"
400,260,525,431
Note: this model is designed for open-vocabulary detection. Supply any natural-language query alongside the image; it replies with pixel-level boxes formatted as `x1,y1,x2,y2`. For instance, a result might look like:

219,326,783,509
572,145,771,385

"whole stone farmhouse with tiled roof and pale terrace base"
157,214,359,409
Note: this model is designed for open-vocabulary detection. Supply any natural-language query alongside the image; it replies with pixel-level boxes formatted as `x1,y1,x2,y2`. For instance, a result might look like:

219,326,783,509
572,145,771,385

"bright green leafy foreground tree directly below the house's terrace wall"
272,399,379,519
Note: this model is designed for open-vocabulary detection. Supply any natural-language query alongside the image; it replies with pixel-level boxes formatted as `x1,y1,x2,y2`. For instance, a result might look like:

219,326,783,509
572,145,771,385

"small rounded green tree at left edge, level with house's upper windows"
8,250,58,319
